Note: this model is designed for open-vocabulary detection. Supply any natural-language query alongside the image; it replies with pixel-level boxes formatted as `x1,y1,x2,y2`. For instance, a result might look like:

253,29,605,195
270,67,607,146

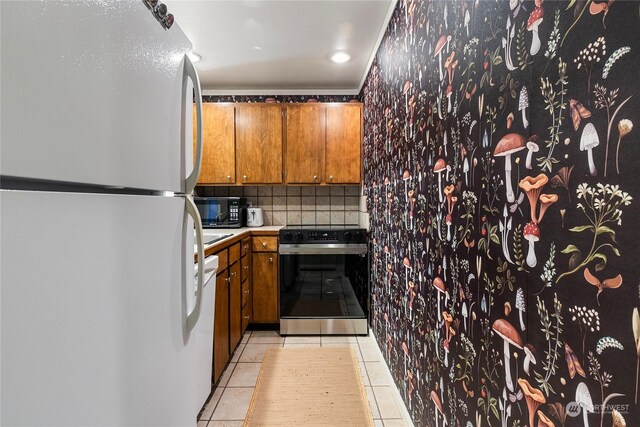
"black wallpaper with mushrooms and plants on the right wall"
362,0,640,427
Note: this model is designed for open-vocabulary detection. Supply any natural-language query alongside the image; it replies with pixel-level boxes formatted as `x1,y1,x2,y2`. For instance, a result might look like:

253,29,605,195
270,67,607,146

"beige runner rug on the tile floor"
244,348,373,427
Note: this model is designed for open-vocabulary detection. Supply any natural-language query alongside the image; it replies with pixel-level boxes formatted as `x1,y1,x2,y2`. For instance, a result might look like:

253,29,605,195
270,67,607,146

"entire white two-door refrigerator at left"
0,0,215,426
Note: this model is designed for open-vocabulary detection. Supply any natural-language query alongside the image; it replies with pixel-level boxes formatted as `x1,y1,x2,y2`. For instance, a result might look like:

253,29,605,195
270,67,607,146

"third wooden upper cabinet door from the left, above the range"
285,104,325,184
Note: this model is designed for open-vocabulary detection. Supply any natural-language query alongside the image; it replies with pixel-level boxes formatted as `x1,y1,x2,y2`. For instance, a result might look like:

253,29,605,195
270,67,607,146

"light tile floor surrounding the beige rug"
198,331,413,427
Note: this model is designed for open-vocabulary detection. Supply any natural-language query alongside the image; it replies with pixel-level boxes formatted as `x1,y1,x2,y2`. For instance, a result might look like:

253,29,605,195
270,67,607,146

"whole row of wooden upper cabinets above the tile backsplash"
194,102,362,185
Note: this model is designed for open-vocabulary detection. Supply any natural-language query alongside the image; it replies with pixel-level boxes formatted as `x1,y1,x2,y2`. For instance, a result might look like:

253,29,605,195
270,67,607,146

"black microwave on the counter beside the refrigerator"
193,197,247,228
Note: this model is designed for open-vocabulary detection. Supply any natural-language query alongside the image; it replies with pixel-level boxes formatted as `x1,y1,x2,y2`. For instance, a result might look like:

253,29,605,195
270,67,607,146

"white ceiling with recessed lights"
165,0,397,95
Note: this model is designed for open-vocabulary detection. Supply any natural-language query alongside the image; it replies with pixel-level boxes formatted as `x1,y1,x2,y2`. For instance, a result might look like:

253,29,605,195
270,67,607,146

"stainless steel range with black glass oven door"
279,226,369,335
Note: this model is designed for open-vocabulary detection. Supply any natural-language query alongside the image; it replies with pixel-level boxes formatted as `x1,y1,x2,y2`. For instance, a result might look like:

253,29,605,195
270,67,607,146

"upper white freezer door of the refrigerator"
0,0,193,192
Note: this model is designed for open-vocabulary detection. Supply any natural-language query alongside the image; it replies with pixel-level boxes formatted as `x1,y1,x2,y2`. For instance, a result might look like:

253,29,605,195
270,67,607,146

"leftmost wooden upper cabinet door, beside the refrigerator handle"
193,102,236,184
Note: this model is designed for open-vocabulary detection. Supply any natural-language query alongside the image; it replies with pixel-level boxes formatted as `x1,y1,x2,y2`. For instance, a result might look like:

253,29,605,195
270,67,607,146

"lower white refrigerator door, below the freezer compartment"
0,190,206,426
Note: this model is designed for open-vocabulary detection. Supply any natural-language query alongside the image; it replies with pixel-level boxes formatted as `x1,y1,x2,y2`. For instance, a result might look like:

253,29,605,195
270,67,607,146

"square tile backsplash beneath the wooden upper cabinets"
197,185,368,227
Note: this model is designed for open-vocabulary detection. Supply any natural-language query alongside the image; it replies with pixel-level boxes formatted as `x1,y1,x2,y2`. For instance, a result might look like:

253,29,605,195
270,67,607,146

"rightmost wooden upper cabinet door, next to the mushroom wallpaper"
324,104,362,184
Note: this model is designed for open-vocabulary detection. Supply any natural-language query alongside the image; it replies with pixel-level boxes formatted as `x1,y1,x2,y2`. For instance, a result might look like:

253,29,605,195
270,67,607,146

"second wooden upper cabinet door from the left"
236,104,283,184
